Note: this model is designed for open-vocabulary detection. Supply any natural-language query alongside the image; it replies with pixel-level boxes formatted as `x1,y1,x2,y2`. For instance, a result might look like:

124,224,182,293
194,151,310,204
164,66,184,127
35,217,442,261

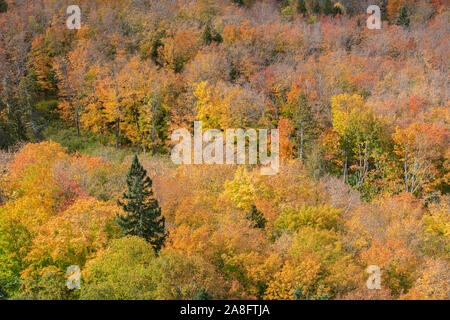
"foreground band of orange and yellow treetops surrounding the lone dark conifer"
0,142,448,299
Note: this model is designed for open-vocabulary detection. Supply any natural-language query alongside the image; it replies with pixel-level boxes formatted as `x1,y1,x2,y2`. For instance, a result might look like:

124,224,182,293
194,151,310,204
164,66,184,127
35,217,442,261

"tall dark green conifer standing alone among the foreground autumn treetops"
116,156,167,252
